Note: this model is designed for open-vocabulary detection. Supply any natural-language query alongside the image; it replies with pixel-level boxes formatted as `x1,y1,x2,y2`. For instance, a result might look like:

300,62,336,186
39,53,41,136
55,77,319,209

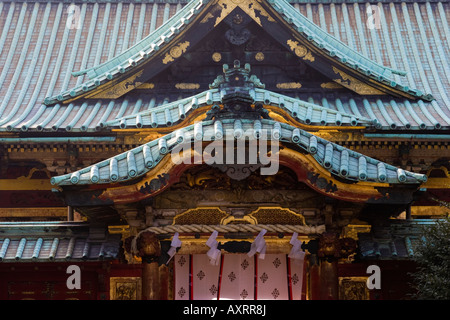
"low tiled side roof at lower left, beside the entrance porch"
0,222,120,263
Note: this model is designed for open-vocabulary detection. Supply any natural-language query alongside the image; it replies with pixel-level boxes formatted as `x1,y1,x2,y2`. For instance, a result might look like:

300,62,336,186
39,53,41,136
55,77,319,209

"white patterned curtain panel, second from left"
192,254,220,300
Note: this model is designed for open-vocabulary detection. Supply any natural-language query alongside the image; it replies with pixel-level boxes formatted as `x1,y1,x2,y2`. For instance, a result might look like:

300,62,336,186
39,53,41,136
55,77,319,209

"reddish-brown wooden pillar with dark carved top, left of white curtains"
136,231,161,300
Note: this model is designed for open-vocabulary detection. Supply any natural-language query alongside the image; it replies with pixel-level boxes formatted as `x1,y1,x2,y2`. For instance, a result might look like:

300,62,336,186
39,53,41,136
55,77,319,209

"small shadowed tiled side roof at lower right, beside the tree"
358,219,434,260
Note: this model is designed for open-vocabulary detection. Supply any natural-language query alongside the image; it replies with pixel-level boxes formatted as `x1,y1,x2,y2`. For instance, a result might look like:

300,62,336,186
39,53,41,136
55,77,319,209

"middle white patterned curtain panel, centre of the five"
219,254,255,300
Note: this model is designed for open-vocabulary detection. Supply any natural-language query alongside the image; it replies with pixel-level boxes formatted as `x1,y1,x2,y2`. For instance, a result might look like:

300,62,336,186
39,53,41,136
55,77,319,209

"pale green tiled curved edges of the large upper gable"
44,0,431,105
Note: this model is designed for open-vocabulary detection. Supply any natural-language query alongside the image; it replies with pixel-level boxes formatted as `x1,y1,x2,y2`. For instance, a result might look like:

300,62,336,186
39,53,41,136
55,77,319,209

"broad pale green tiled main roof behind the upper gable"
0,1,450,132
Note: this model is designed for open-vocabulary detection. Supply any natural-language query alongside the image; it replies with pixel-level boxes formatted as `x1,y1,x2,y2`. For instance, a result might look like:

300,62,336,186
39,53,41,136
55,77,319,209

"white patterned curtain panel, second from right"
256,254,289,300
